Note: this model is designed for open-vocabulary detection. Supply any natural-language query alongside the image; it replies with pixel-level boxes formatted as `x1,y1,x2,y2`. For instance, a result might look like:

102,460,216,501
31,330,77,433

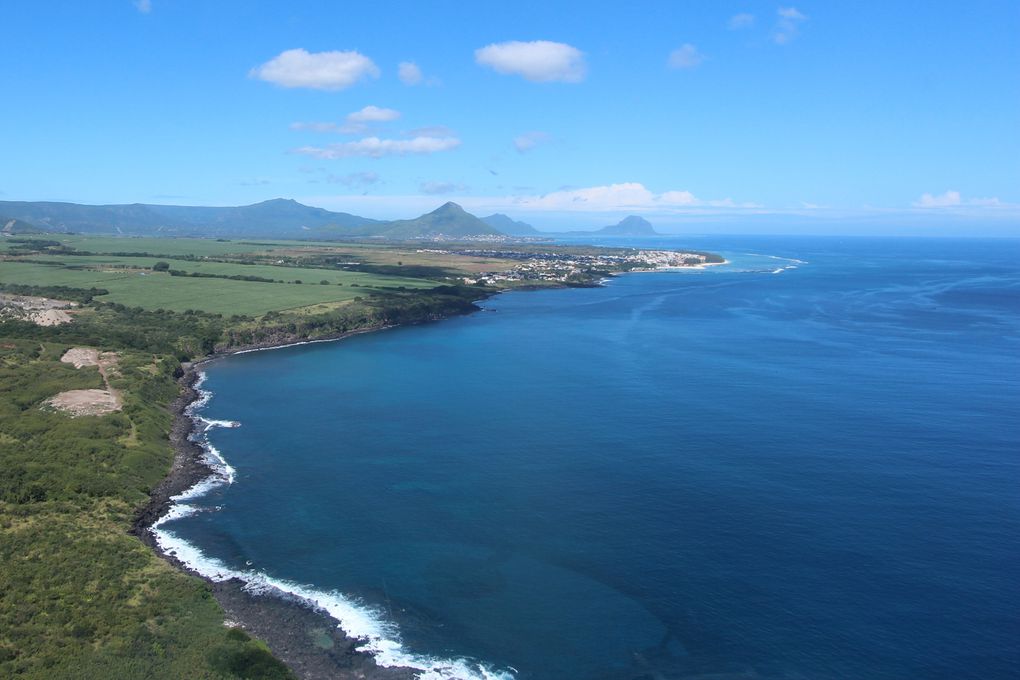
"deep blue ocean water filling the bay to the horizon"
163,237,1020,680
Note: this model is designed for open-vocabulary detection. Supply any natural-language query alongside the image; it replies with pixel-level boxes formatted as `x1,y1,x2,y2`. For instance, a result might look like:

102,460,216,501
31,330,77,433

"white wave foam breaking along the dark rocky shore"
150,373,516,680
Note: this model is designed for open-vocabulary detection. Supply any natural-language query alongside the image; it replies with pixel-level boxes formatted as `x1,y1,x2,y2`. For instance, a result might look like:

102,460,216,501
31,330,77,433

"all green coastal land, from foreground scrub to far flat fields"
0,232,505,680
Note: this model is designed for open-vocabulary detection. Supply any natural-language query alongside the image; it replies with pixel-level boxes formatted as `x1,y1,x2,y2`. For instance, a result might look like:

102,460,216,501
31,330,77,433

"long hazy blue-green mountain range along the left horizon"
0,199,377,239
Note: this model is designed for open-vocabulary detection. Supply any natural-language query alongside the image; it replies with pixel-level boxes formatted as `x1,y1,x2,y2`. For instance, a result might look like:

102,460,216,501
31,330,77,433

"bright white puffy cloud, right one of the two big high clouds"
474,40,587,83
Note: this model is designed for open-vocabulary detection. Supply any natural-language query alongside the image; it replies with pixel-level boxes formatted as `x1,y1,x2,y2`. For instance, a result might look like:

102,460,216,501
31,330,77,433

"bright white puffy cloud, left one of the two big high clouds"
248,49,379,90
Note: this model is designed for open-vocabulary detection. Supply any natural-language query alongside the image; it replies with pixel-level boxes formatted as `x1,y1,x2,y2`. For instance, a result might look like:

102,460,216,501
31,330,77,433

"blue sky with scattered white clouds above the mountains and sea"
0,0,1020,236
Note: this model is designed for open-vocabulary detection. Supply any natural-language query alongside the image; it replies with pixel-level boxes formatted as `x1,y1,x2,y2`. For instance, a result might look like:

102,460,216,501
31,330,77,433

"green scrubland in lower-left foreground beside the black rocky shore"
0,342,292,680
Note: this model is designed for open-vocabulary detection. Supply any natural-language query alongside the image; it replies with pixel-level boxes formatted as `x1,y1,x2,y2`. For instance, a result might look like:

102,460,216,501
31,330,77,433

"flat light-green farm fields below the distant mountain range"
0,234,508,317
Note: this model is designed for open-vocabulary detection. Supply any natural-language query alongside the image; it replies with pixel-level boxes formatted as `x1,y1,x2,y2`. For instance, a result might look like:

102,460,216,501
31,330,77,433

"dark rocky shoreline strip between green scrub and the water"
131,325,420,680
